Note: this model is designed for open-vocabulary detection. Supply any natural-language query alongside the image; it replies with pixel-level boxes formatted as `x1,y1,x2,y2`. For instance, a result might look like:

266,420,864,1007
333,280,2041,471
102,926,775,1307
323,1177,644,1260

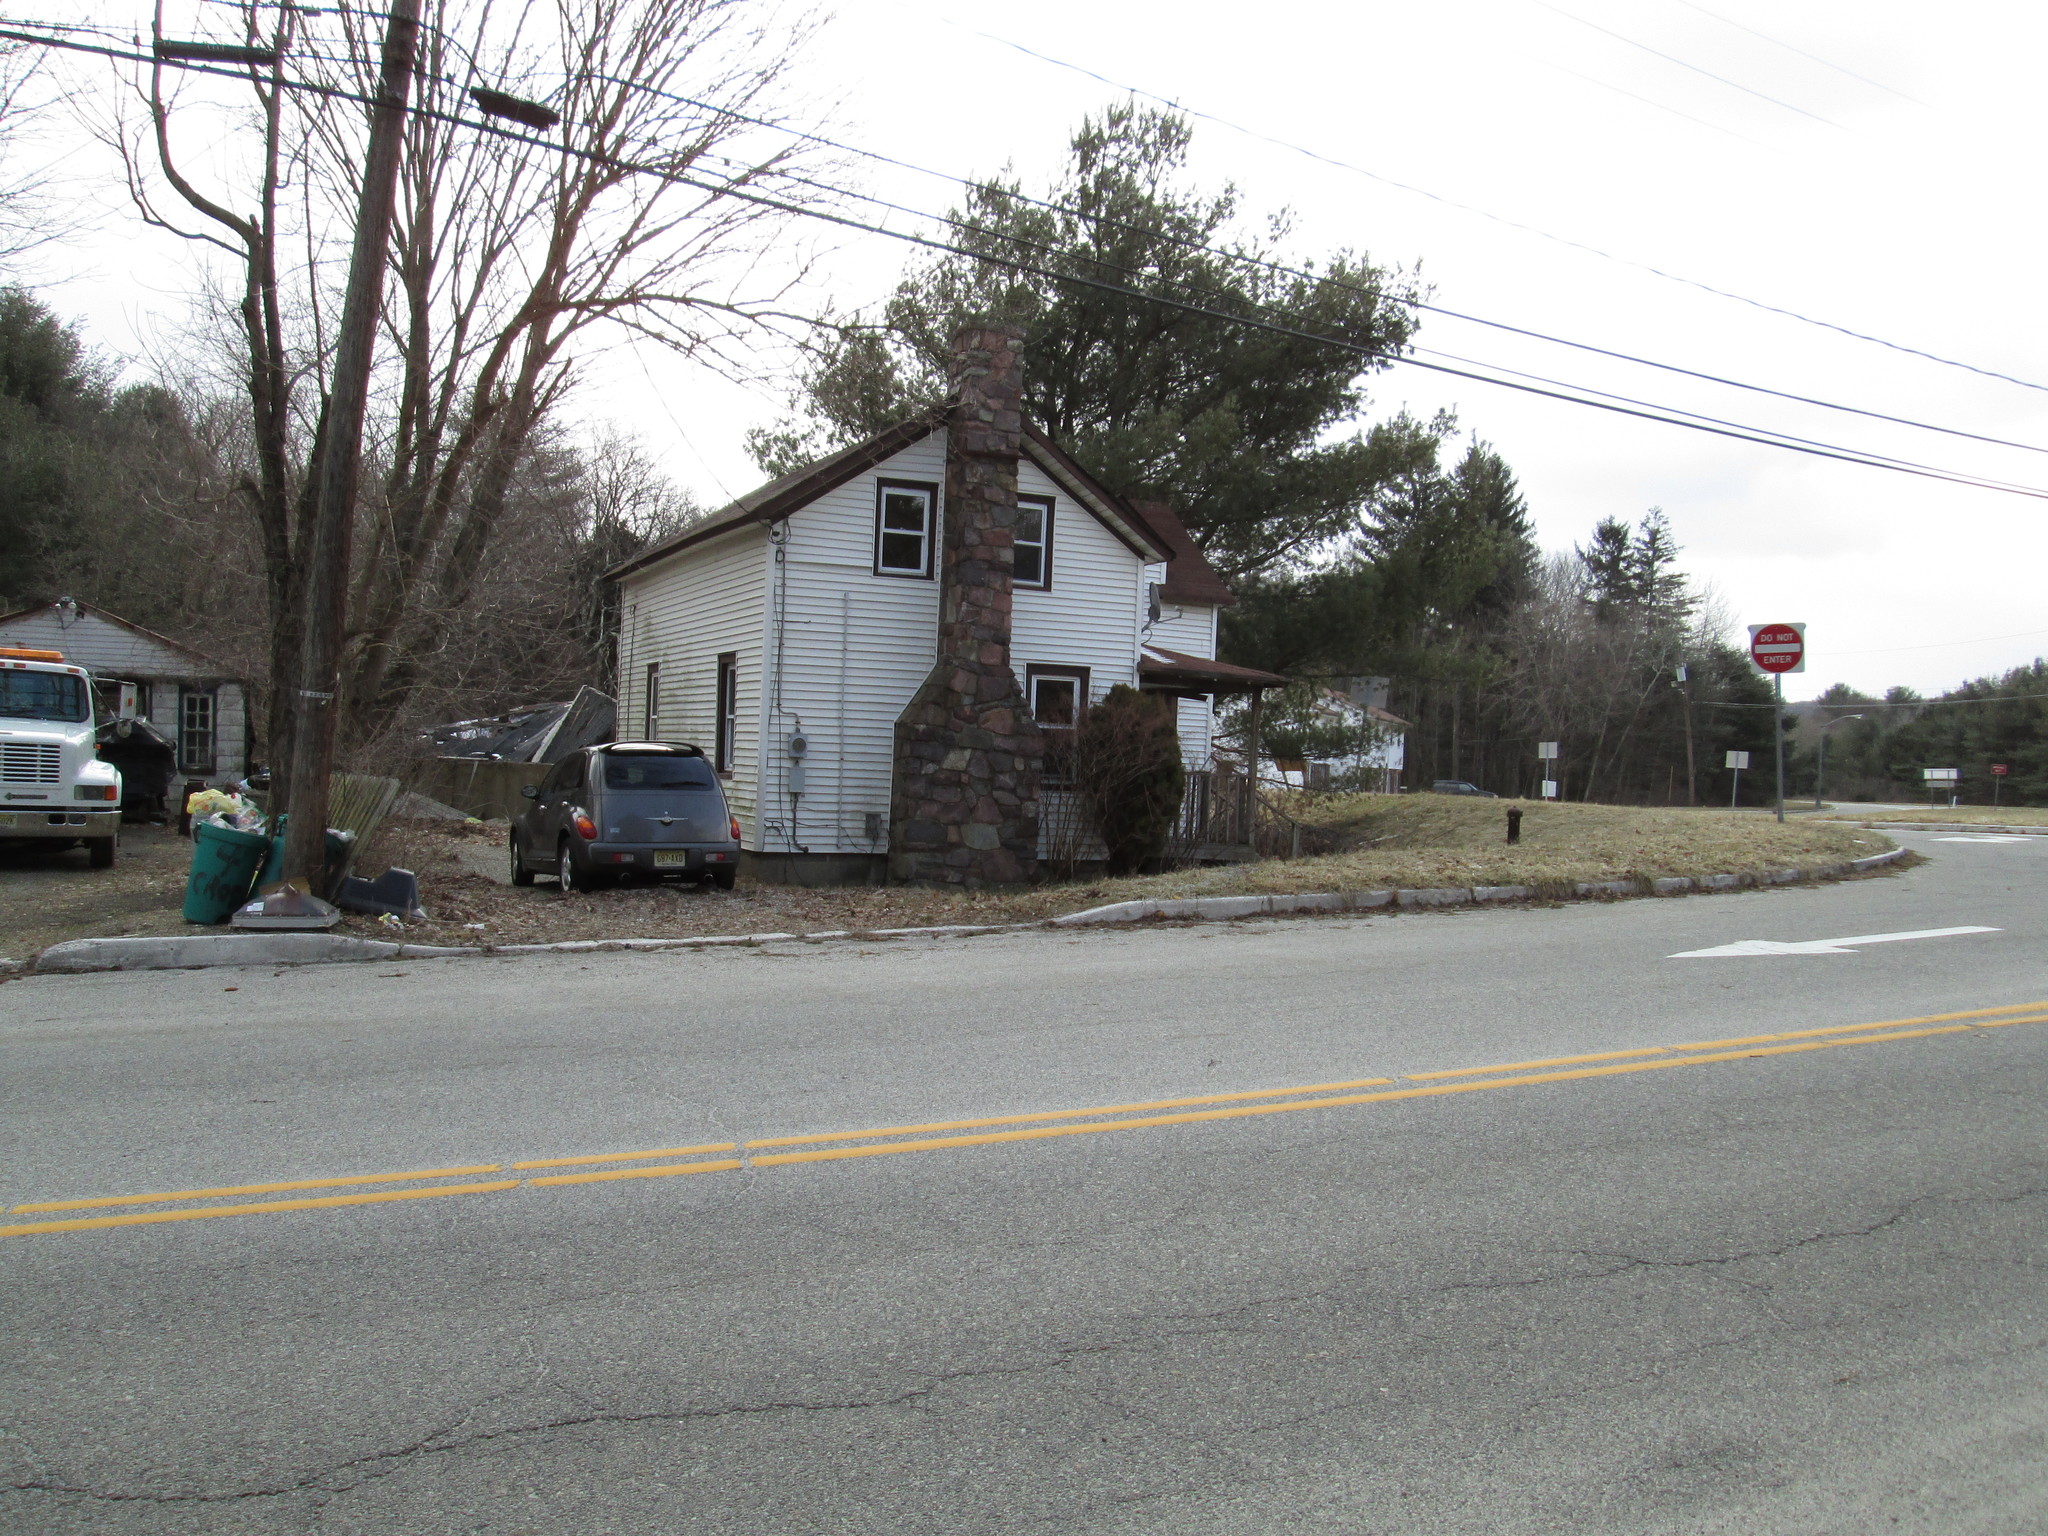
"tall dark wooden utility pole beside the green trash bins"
279,0,420,926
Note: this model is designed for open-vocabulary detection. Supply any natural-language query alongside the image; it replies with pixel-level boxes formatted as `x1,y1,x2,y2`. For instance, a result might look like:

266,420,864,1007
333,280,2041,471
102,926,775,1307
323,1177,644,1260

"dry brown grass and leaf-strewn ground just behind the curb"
0,795,1890,961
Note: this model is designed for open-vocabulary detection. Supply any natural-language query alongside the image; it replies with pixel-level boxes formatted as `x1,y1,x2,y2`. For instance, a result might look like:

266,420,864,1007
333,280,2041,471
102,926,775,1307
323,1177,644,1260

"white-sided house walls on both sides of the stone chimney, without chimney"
610,348,1282,881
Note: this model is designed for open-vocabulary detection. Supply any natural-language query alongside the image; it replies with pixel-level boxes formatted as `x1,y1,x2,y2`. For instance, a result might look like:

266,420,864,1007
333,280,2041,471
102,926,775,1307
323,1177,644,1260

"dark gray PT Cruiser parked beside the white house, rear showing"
510,741,739,891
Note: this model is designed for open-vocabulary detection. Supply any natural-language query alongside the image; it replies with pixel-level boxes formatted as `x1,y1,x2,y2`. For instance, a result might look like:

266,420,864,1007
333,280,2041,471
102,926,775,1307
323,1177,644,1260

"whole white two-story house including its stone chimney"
610,332,1282,883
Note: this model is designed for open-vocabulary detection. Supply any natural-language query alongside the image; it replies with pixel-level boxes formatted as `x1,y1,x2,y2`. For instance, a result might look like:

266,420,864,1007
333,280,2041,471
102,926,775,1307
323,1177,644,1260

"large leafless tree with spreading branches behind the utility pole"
104,0,817,770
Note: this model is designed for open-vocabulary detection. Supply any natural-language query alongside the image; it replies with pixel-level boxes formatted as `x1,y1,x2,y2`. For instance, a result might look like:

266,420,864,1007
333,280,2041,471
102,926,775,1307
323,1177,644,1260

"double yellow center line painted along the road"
0,1001,2048,1237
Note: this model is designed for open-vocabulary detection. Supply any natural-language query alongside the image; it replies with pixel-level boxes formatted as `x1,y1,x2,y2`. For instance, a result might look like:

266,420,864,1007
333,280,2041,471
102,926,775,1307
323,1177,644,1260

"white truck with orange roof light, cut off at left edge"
0,647,121,868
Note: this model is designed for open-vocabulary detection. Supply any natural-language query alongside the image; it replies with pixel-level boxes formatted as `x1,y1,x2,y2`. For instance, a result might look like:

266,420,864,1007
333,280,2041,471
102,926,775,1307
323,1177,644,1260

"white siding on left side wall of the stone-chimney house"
618,526,772,852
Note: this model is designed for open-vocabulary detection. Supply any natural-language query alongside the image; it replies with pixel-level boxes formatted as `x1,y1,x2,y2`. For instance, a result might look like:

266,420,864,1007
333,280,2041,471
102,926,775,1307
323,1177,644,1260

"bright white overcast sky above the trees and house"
29,0,2048,696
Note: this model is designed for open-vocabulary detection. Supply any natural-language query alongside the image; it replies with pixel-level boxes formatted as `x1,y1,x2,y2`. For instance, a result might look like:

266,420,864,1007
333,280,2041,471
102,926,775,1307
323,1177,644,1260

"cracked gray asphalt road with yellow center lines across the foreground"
0,834,2048,1536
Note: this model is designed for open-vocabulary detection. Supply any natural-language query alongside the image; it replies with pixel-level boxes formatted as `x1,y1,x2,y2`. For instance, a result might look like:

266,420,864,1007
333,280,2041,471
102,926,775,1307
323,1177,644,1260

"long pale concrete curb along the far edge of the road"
27,848,1907,975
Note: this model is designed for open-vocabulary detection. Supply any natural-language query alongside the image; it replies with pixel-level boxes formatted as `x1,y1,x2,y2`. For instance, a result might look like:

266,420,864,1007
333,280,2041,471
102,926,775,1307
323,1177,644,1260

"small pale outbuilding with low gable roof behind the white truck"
0,598,250,782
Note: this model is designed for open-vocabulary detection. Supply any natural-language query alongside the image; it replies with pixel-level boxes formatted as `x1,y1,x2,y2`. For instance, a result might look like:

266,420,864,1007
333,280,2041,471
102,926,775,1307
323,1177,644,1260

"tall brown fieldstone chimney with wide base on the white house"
889,324,1044,885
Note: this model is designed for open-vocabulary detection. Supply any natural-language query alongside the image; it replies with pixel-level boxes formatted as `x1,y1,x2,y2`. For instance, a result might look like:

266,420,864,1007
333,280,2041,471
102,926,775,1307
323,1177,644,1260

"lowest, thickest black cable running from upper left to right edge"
16,29,2048,500
